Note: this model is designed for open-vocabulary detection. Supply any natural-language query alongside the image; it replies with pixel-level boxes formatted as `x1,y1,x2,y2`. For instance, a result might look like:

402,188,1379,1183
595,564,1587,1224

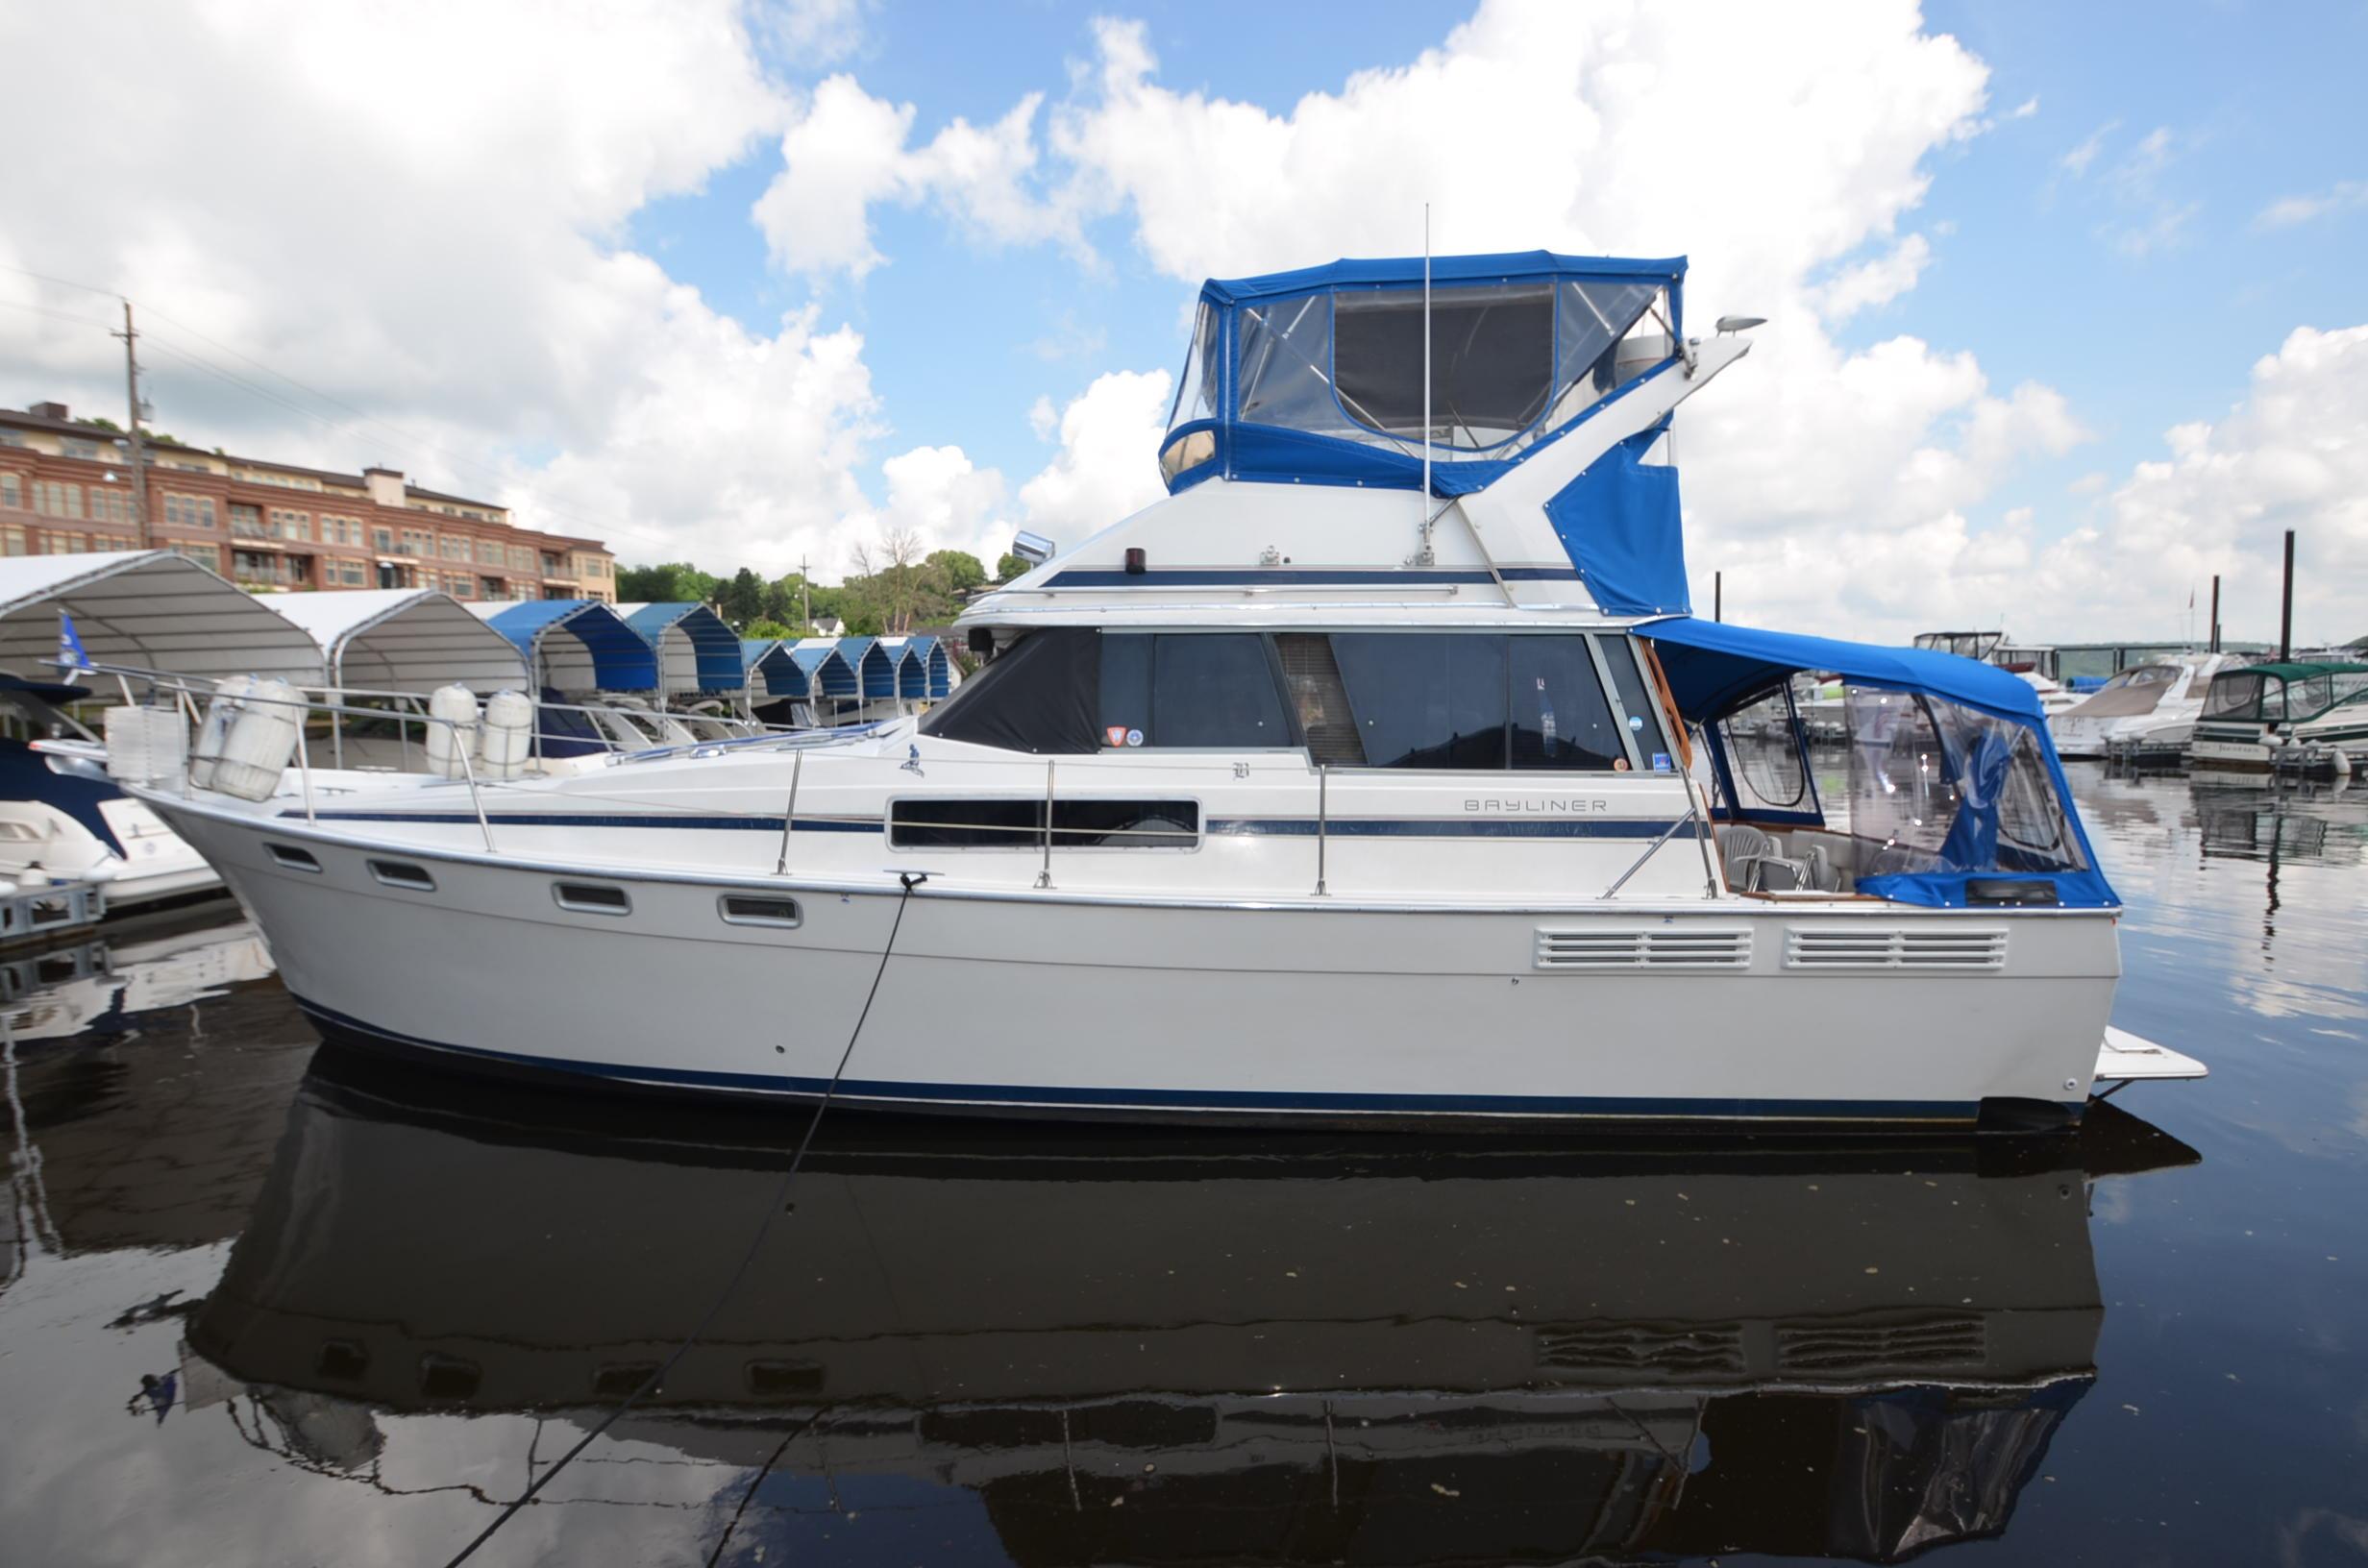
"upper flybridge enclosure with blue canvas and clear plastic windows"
1160,251,1686,495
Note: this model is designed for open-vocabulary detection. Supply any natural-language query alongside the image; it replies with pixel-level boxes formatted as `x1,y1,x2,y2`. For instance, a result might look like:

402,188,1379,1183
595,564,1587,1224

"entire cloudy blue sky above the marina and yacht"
0,0,2368,637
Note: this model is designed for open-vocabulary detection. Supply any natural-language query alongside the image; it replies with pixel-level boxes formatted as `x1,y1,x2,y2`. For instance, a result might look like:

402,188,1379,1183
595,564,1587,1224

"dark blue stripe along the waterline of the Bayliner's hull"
296,997,1982,1123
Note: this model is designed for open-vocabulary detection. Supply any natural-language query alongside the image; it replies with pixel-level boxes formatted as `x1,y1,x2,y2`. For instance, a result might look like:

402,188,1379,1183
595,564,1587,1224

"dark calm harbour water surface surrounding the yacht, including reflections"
0,768,2368,1568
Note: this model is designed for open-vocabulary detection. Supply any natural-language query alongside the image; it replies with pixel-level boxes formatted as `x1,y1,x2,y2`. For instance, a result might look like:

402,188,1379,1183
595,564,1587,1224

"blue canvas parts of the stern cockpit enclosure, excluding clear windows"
1637,618,2122,910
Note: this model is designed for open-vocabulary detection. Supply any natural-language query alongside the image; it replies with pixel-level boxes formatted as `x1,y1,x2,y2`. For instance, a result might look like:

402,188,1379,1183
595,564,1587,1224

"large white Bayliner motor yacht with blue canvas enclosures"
124,251,2203,1130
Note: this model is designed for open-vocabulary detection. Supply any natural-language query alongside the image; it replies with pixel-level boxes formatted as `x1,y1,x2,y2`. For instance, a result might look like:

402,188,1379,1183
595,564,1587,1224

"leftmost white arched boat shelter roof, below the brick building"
0,550,325,684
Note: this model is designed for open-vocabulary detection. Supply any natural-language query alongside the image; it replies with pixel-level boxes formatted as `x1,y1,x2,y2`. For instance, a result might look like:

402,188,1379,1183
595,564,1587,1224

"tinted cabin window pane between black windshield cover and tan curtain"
1101,632,1293,748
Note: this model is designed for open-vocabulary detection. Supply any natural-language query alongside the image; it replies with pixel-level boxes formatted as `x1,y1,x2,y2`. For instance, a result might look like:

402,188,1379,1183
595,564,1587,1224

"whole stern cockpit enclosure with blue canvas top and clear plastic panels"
1639,618,2119,907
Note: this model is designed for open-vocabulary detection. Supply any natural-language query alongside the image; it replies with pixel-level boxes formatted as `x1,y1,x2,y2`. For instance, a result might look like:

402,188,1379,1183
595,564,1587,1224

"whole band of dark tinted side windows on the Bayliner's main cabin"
921,627,1672,772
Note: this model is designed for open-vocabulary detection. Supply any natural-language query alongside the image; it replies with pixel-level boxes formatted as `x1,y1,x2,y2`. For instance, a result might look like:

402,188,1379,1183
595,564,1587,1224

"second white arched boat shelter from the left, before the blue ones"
272,587,528,697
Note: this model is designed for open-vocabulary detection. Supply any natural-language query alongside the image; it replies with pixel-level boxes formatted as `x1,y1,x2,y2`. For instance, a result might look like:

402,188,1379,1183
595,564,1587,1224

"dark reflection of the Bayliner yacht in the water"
185,1052,2195,1563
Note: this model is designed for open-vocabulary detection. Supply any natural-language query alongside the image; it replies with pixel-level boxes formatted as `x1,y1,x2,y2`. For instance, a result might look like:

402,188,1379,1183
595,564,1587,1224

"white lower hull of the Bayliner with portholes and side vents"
149,796,2119,1127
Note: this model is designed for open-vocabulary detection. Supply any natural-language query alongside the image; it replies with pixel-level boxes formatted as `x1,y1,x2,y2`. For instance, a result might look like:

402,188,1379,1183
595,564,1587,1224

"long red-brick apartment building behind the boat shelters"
0,403,616,604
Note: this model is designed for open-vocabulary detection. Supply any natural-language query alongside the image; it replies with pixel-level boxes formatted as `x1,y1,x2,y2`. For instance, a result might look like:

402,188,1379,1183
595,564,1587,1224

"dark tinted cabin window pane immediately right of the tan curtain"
1333,632,1506,768
